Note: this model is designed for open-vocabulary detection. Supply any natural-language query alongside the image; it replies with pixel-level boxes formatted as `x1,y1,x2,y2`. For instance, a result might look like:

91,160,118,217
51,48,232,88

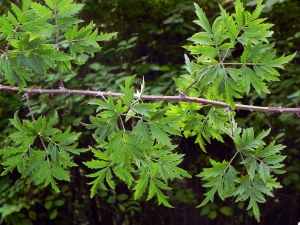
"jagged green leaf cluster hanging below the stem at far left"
0,112,86,192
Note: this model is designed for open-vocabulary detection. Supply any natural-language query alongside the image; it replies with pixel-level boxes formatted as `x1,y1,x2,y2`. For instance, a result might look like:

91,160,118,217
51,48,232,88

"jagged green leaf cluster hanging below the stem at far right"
197,127,285,221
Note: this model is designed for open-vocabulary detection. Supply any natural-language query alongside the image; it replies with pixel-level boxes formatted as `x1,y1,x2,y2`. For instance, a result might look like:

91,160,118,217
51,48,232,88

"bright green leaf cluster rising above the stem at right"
179,1,295,109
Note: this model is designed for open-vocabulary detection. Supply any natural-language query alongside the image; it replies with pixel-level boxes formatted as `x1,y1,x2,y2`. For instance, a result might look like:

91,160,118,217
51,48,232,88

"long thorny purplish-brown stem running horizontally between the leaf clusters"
0,84,300,114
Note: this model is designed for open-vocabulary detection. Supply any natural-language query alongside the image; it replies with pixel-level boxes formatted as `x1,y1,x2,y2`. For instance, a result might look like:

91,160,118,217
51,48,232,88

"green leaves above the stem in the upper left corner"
0,0,116,88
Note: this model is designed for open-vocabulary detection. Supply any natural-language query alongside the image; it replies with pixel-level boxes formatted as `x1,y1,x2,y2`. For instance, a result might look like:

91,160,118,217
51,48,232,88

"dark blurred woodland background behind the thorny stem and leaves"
0,0,300,225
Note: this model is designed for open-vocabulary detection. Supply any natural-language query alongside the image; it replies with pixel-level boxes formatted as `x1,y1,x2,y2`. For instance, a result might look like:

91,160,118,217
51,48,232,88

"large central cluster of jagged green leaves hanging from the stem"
85,76,190,207
